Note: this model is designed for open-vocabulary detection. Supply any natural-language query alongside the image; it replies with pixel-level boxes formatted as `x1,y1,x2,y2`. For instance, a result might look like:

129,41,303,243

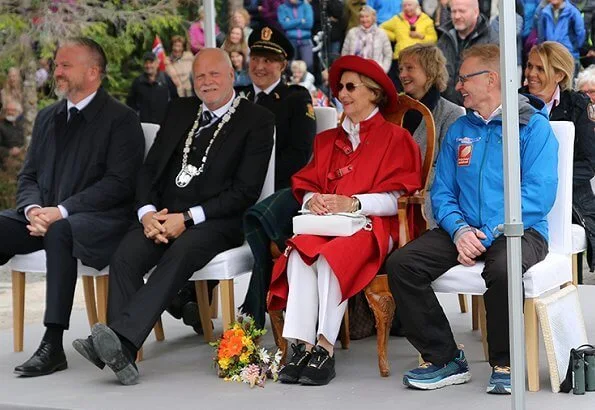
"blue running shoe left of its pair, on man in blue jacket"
403,350,471,390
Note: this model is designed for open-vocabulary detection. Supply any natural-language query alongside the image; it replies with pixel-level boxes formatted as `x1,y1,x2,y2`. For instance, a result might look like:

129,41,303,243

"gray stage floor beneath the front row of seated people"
0,286,595,410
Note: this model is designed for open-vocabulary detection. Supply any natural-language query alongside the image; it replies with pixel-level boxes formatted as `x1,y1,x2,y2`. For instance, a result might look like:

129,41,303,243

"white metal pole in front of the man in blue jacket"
500,0,525,410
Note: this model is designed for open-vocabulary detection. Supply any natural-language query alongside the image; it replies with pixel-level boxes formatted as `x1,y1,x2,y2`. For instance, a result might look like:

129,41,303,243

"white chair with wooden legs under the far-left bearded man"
8,123,159,352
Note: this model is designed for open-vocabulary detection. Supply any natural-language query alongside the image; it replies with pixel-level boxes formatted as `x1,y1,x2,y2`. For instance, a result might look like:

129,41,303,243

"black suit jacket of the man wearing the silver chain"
136,98,274,235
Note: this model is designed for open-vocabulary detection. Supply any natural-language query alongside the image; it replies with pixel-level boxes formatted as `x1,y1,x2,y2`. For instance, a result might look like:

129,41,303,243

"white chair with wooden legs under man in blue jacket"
432,121,574,391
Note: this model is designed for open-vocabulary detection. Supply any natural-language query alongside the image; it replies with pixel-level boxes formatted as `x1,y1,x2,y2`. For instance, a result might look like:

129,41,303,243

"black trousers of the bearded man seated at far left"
0,217,77,329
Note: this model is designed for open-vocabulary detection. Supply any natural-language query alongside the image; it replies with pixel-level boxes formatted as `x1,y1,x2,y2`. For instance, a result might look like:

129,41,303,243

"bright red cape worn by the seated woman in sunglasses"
268,113,421,310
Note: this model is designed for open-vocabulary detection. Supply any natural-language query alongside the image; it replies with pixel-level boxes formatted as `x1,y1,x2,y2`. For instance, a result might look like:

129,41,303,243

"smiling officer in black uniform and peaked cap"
238,26,316,190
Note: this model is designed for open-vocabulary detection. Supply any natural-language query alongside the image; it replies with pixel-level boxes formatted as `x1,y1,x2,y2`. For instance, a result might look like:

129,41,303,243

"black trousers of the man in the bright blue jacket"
386,228,548,366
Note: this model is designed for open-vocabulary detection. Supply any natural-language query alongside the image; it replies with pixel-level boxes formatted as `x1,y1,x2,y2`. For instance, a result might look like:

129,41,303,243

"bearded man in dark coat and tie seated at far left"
0,38,144,376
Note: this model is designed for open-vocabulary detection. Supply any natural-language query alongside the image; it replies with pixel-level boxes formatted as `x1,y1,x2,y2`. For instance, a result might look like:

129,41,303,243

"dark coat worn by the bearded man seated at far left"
0,88,145,269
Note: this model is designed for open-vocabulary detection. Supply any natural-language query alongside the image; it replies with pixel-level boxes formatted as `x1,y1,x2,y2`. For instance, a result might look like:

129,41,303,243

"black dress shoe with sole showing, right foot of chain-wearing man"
91,323,138,385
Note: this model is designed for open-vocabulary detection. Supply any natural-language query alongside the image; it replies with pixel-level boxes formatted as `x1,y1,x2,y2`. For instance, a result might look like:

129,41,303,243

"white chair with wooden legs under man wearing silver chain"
189,130,275,342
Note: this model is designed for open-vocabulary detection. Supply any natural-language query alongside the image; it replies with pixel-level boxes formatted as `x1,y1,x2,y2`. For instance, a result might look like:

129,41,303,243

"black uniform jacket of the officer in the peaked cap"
237,81,316,191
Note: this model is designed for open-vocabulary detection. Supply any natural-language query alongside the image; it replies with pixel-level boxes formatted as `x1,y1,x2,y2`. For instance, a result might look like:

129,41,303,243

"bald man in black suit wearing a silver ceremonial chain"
73,49,274,384
